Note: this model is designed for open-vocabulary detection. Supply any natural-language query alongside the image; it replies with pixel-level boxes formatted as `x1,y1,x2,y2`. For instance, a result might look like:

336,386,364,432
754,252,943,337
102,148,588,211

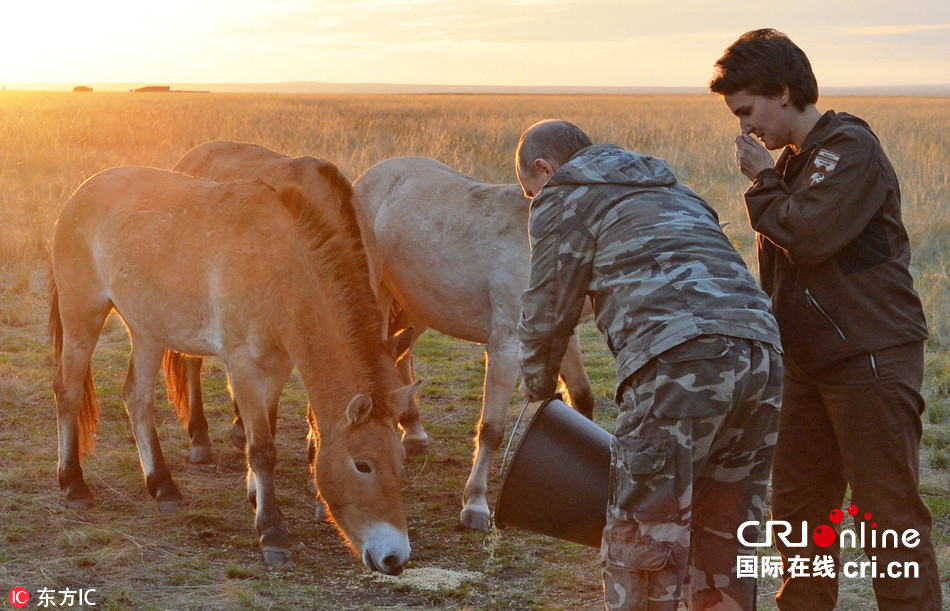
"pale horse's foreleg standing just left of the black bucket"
460,336,518,531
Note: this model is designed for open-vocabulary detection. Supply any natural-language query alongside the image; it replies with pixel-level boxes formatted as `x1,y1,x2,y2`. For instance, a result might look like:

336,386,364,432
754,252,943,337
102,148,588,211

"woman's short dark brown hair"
709,28,818,110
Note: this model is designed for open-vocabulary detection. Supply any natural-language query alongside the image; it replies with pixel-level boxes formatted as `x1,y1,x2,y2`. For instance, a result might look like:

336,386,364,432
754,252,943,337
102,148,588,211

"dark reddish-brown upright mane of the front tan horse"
281,158,391,416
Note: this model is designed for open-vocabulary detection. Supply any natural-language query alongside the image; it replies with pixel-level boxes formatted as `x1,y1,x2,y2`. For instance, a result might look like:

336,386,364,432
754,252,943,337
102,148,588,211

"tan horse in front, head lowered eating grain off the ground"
50,164,415,574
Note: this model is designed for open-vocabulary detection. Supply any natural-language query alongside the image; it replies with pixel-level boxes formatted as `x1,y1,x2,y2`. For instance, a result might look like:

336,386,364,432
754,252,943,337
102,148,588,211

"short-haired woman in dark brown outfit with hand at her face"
710,29,941,611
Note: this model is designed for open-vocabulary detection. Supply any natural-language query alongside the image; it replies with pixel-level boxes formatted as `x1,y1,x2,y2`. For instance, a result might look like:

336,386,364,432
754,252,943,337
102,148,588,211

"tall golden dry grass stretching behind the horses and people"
0,92,950,608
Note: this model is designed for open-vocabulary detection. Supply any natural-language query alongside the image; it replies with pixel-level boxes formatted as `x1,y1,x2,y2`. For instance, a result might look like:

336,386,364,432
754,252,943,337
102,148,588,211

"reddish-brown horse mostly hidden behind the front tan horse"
165,140,424,468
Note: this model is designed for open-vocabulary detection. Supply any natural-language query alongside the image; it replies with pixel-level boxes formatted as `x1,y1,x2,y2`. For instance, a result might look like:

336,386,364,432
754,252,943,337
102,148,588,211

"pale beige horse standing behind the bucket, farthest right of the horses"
353,157,594,530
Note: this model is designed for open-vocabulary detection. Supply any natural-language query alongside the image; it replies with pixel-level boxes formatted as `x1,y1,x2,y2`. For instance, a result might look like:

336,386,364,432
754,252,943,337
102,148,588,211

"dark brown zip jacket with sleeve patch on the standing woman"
745,111,927,371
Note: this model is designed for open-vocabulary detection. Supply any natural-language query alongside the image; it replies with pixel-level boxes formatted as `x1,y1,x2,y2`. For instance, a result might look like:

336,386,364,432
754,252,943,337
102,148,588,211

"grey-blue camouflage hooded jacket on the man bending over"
518,145,780,397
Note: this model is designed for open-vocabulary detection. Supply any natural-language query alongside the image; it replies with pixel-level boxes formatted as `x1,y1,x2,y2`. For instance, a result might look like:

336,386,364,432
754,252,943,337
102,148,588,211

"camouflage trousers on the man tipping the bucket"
601,335,782,611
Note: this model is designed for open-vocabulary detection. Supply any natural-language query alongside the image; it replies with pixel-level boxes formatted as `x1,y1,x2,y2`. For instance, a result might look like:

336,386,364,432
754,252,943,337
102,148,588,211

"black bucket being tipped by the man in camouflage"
495,399,612,548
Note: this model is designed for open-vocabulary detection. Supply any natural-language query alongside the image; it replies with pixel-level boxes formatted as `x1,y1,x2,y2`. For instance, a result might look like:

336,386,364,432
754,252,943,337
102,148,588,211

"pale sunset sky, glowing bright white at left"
0,0,950,87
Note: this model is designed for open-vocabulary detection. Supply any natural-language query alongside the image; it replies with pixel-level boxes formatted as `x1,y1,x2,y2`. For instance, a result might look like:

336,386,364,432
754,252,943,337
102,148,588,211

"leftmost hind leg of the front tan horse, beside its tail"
53,303,111,509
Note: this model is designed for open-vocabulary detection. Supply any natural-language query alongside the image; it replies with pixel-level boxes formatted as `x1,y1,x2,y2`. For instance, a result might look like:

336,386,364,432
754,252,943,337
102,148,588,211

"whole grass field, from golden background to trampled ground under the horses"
0,92,950,610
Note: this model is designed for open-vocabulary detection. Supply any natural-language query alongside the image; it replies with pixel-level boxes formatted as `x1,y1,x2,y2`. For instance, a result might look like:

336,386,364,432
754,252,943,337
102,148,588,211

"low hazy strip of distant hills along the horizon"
7,81,950,96
